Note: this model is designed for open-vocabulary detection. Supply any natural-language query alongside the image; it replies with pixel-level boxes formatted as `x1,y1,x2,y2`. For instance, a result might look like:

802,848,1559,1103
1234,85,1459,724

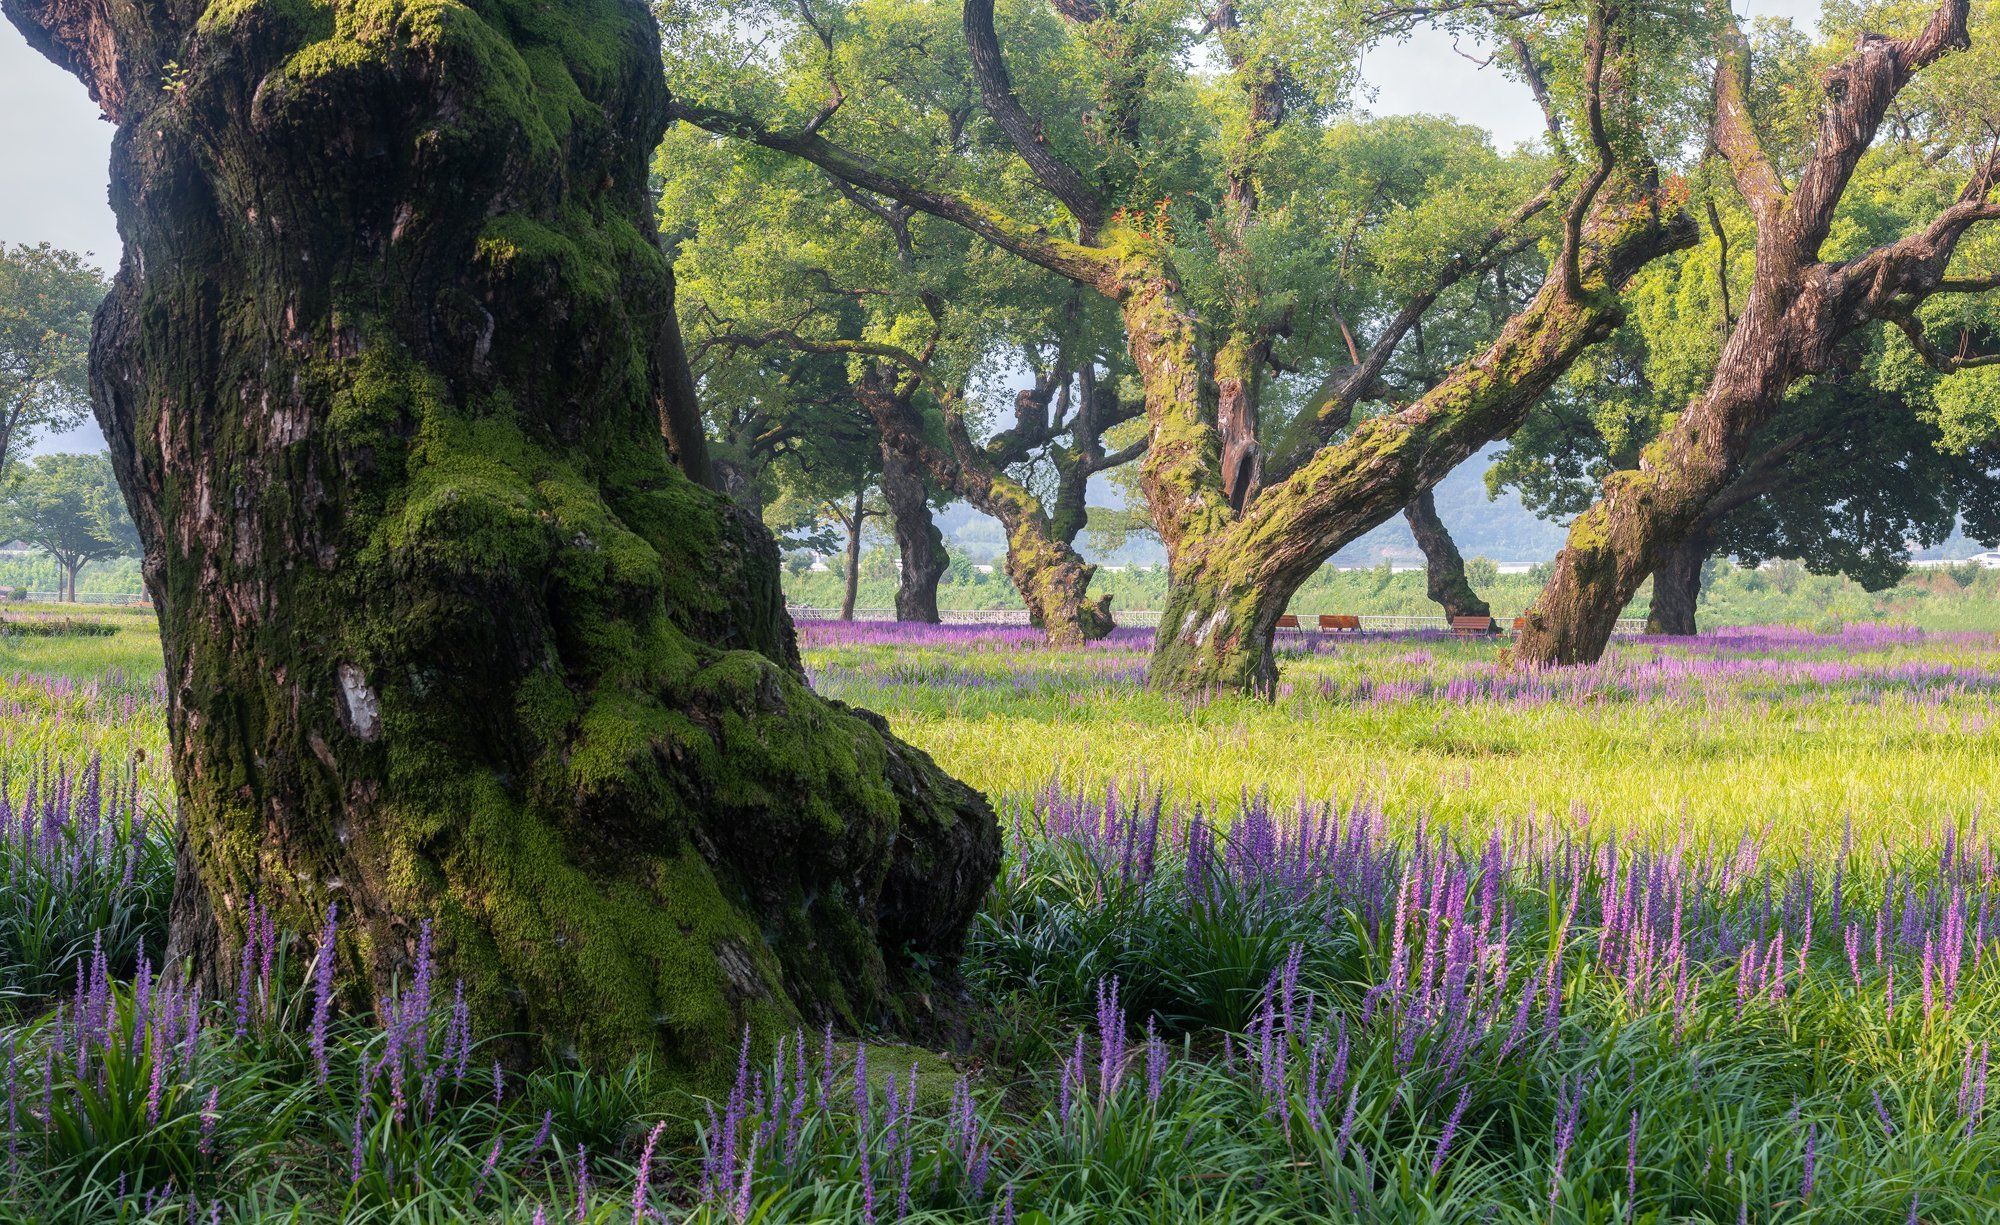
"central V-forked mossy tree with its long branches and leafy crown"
678,0,1692,691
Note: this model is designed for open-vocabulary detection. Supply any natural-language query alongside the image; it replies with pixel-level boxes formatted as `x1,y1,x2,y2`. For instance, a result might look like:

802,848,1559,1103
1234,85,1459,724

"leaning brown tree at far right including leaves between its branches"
1516,0,2000,663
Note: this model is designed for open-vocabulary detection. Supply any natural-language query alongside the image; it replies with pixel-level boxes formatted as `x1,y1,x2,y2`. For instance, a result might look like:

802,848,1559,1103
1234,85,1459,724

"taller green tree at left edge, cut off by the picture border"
0,242,104,478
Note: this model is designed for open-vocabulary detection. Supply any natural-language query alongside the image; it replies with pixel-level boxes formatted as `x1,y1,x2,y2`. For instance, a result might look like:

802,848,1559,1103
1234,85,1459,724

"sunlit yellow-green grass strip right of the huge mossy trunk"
806,635,2000,843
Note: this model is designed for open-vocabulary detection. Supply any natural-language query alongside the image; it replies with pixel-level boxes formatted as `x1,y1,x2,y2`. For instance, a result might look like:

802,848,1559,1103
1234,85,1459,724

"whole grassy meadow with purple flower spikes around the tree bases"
0,608,2000,1225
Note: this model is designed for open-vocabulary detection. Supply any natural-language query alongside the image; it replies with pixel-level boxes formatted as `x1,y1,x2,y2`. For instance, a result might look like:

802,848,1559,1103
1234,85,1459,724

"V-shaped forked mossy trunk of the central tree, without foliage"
1126,180,1694,693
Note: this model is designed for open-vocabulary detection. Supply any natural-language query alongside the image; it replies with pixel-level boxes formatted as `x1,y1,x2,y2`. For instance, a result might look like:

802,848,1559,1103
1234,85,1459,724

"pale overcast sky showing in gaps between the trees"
0,0,1818,450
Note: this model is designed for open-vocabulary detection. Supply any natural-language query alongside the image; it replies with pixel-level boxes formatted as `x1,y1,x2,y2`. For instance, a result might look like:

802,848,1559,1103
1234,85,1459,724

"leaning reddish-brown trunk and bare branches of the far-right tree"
1516,0,2000,665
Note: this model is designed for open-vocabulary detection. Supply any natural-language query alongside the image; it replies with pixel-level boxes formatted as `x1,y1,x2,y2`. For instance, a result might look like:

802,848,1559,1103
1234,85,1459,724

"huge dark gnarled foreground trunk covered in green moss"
4,0,998,1081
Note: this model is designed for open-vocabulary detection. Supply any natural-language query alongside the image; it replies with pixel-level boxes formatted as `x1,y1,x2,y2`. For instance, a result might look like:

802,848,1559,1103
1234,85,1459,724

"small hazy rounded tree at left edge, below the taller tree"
0,452,138,602
